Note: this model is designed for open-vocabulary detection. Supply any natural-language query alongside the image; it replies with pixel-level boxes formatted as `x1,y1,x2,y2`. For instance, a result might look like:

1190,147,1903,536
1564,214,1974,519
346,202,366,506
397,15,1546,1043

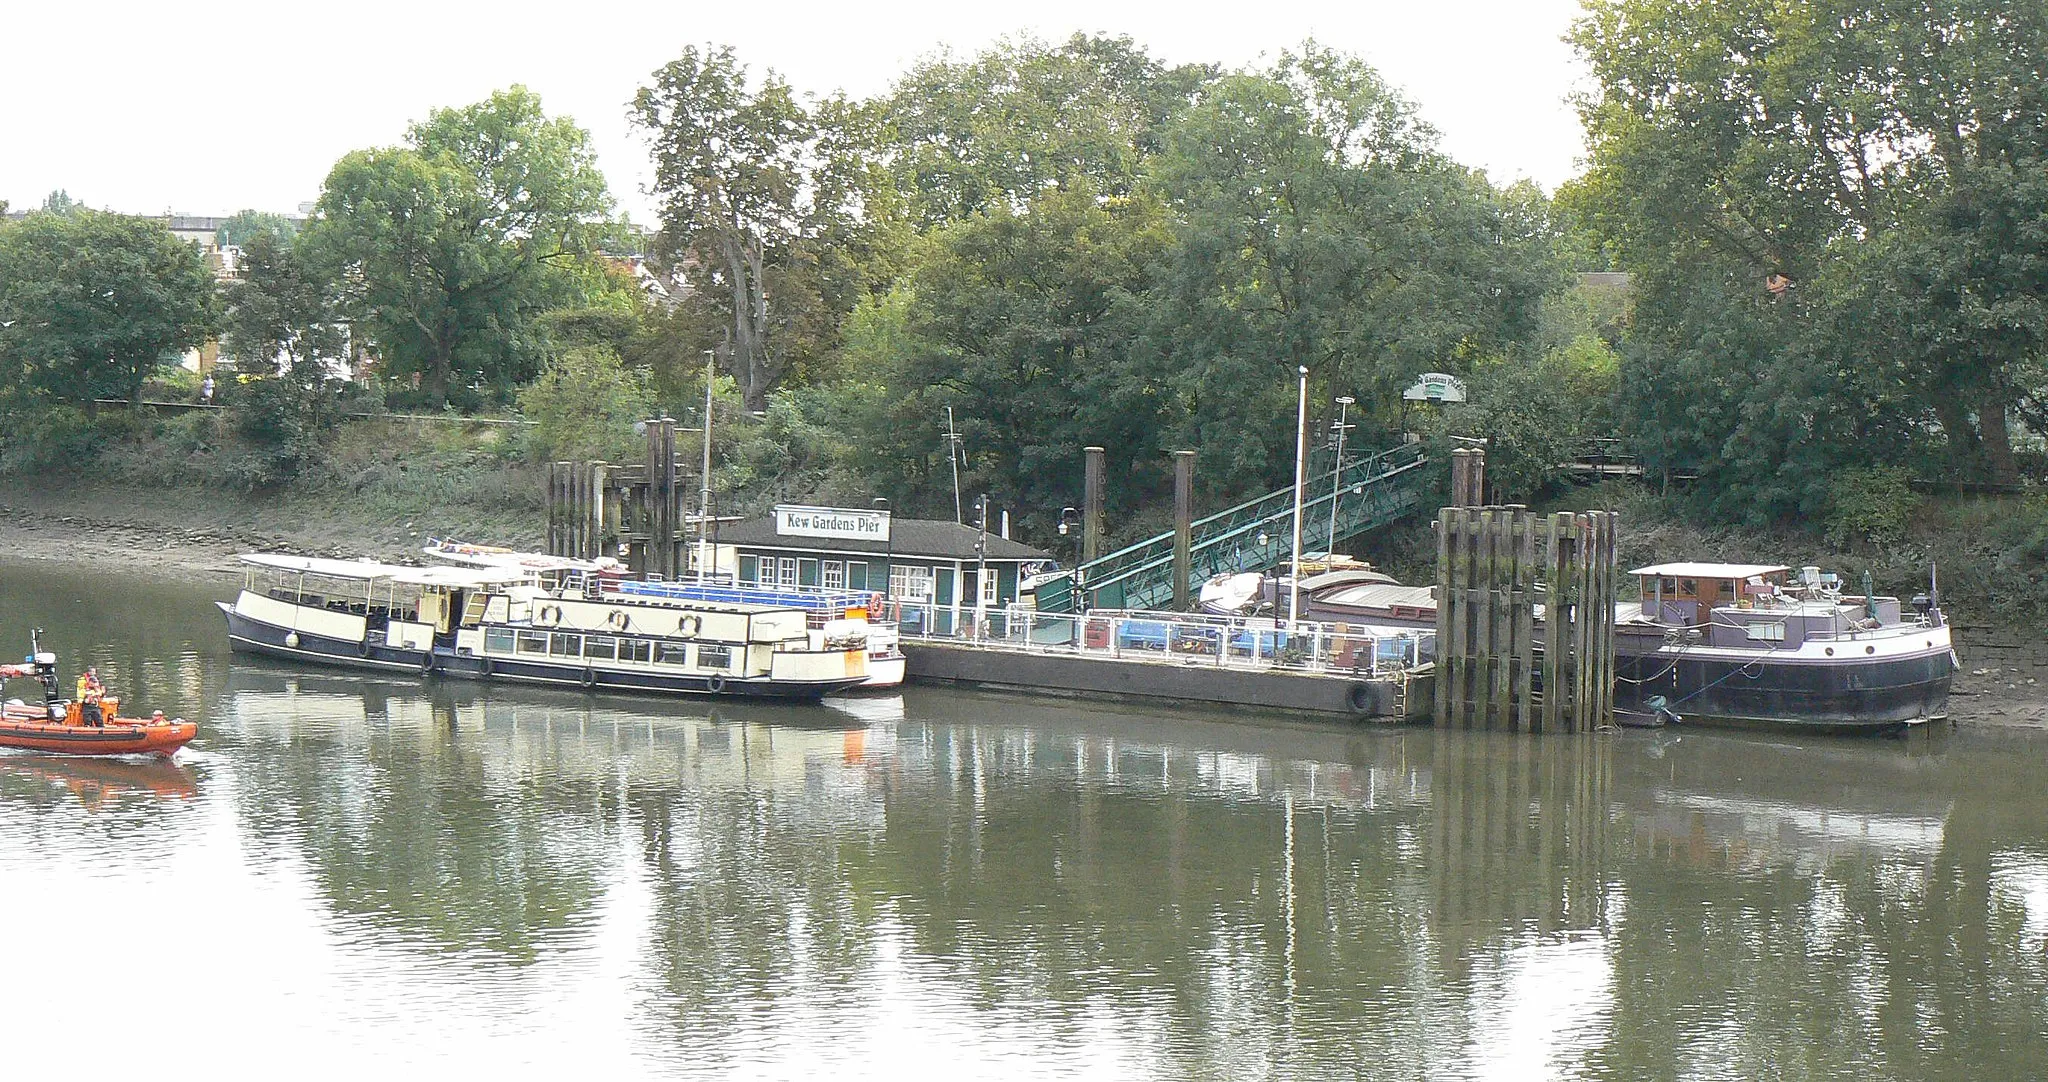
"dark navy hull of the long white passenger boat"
215,602,866,703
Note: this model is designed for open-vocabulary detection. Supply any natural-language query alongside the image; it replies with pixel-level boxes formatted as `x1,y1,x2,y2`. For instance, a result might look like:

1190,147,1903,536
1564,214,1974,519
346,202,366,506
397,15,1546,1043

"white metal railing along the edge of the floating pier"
885,602,1436,676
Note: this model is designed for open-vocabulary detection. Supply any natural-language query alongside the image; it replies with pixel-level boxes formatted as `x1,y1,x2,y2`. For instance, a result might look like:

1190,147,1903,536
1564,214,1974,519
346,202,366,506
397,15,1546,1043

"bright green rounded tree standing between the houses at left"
301,86,612,406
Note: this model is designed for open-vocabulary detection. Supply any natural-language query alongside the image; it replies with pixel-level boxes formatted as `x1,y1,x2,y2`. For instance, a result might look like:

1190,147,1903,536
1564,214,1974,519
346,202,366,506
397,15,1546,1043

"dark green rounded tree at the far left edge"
0,207,217,402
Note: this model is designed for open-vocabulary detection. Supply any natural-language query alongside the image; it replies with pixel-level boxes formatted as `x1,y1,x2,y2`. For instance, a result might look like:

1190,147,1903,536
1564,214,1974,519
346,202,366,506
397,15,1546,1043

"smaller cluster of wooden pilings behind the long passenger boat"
547,418,690,578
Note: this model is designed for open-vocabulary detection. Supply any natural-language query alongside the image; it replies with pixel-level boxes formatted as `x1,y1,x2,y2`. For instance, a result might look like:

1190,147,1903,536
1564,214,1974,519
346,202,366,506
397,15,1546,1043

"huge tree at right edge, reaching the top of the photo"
1573,0,2048,489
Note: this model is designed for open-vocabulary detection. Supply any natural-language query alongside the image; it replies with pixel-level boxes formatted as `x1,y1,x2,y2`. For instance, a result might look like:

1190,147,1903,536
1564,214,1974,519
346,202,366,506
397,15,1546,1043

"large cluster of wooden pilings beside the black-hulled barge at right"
1432,506,1616,732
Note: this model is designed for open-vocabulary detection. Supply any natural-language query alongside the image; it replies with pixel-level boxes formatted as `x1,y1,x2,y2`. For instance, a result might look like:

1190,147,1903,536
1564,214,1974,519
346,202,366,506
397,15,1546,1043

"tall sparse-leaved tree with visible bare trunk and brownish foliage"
633,47,893,410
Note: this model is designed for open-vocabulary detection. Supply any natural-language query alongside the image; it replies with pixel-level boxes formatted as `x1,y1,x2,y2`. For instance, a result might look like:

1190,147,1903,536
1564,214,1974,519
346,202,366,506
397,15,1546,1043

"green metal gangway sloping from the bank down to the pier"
1036,445,1427,613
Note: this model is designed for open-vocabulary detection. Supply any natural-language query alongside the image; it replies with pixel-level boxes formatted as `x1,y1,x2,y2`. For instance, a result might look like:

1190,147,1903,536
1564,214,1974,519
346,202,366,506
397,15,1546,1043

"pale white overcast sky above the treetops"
0,0,1583,223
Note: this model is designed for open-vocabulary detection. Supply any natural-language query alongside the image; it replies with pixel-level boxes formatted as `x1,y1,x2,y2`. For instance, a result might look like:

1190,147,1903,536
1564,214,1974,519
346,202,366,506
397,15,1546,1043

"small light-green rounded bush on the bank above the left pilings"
518,346,653,461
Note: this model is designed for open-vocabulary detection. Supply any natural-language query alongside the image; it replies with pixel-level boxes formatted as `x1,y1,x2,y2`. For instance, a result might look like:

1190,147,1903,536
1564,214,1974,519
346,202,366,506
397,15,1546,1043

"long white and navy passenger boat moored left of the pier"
219,553,868,699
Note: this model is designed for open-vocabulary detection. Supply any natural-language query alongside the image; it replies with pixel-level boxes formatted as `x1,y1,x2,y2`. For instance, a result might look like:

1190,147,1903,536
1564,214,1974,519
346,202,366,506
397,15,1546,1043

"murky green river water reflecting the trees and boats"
0,564,2048,1080
